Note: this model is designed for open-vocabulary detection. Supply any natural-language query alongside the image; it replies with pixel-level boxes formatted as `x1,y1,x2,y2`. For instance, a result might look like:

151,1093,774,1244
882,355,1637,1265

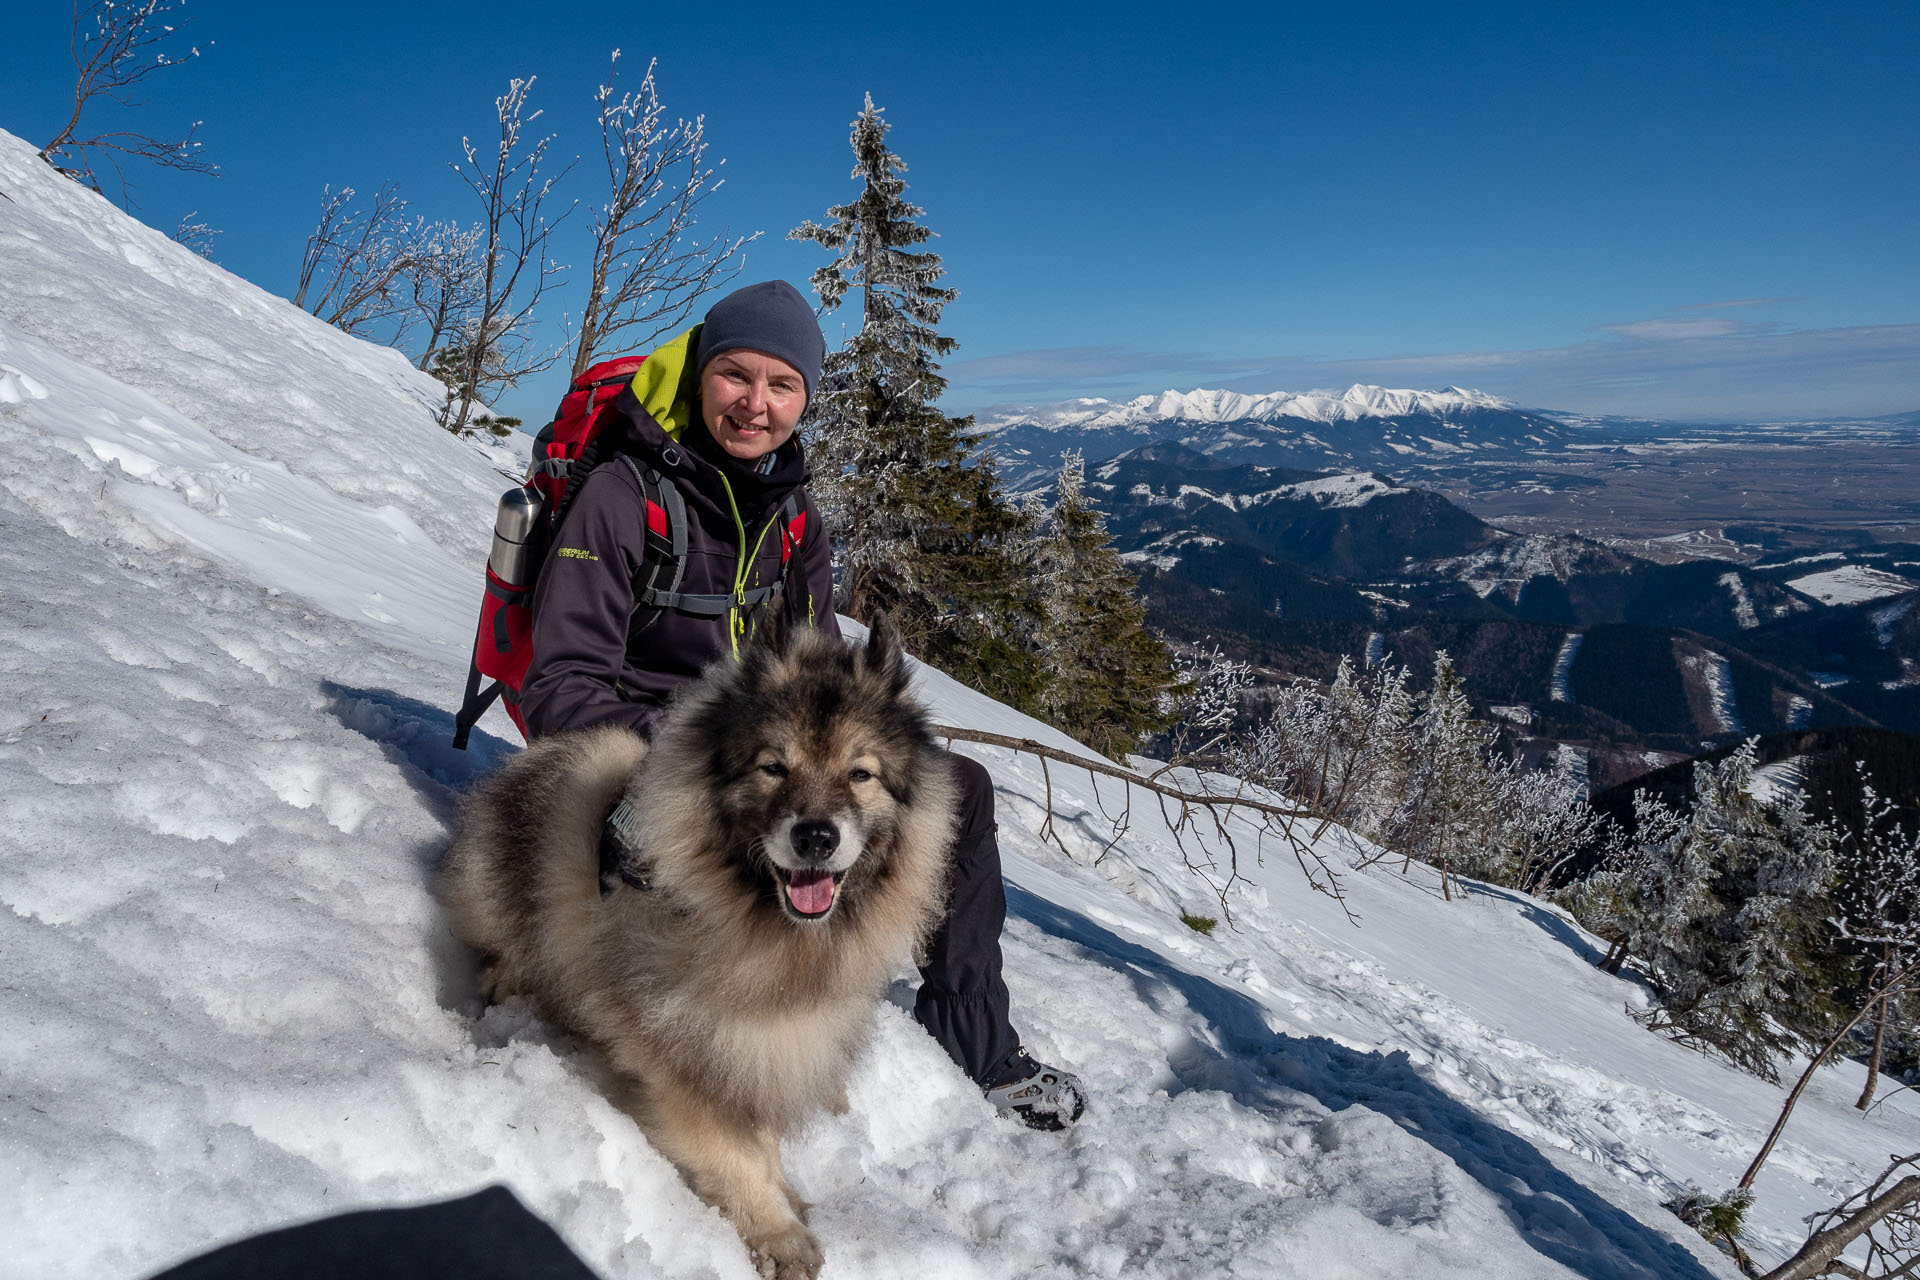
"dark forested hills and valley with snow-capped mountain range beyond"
981,388,1920,791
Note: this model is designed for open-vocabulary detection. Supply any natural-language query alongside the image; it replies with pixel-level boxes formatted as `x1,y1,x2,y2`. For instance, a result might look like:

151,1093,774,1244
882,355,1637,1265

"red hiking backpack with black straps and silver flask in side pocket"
453,355,806,750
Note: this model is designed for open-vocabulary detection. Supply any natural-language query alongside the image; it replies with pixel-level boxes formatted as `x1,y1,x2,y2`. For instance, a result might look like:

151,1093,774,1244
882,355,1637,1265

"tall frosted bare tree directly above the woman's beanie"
572,50,758,378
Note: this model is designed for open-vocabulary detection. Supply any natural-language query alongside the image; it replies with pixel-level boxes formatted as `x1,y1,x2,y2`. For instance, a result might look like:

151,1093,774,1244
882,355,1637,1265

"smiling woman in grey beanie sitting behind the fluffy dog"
520,280,1085,1128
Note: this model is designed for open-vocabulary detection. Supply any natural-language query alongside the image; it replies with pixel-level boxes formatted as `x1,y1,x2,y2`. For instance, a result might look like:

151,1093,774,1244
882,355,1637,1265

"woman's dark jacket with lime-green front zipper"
520,391,839,737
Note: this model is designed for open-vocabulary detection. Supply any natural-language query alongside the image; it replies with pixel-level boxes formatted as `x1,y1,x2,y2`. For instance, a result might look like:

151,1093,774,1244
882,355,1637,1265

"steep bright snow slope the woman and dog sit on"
0,134,1920,1280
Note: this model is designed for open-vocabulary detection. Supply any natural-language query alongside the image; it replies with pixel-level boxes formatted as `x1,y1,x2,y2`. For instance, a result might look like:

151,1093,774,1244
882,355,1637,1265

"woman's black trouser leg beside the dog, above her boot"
914,756,1020,1084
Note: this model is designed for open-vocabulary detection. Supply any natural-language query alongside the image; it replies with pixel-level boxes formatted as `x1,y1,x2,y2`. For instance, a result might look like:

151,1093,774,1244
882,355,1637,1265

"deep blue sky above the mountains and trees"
0,0,1920,418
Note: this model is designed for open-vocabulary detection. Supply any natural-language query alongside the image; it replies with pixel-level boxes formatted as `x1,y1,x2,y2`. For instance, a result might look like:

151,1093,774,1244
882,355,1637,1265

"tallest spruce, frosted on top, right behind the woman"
789,94,1044,710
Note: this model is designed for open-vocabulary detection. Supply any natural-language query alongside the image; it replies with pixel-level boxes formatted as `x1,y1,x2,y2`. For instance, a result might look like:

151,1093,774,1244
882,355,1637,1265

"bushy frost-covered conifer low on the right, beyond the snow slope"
1626,739,1836,1080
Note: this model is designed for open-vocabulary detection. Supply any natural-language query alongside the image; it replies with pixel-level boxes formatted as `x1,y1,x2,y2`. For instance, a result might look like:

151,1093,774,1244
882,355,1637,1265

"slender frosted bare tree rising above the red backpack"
430,77,572,436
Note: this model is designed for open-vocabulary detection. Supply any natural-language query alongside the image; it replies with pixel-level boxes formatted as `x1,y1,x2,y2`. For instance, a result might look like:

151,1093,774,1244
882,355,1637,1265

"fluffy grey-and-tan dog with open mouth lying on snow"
440,620,956,1280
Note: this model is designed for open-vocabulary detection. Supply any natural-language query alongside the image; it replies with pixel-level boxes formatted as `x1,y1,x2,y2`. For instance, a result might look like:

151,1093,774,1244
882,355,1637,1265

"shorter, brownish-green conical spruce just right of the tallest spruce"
1033,451,1177,760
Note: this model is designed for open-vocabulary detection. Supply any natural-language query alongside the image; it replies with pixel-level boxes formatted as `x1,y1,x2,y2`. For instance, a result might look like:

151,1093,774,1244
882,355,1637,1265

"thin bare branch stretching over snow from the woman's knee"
933,725,1354,923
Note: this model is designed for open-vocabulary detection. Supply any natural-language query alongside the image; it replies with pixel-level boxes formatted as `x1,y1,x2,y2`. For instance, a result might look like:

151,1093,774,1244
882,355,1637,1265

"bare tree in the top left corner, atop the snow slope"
40,0,219,201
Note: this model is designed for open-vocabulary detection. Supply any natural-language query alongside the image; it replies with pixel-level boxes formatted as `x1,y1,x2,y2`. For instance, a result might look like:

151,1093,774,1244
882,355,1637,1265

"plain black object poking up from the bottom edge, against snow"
154,1186,599,1280
